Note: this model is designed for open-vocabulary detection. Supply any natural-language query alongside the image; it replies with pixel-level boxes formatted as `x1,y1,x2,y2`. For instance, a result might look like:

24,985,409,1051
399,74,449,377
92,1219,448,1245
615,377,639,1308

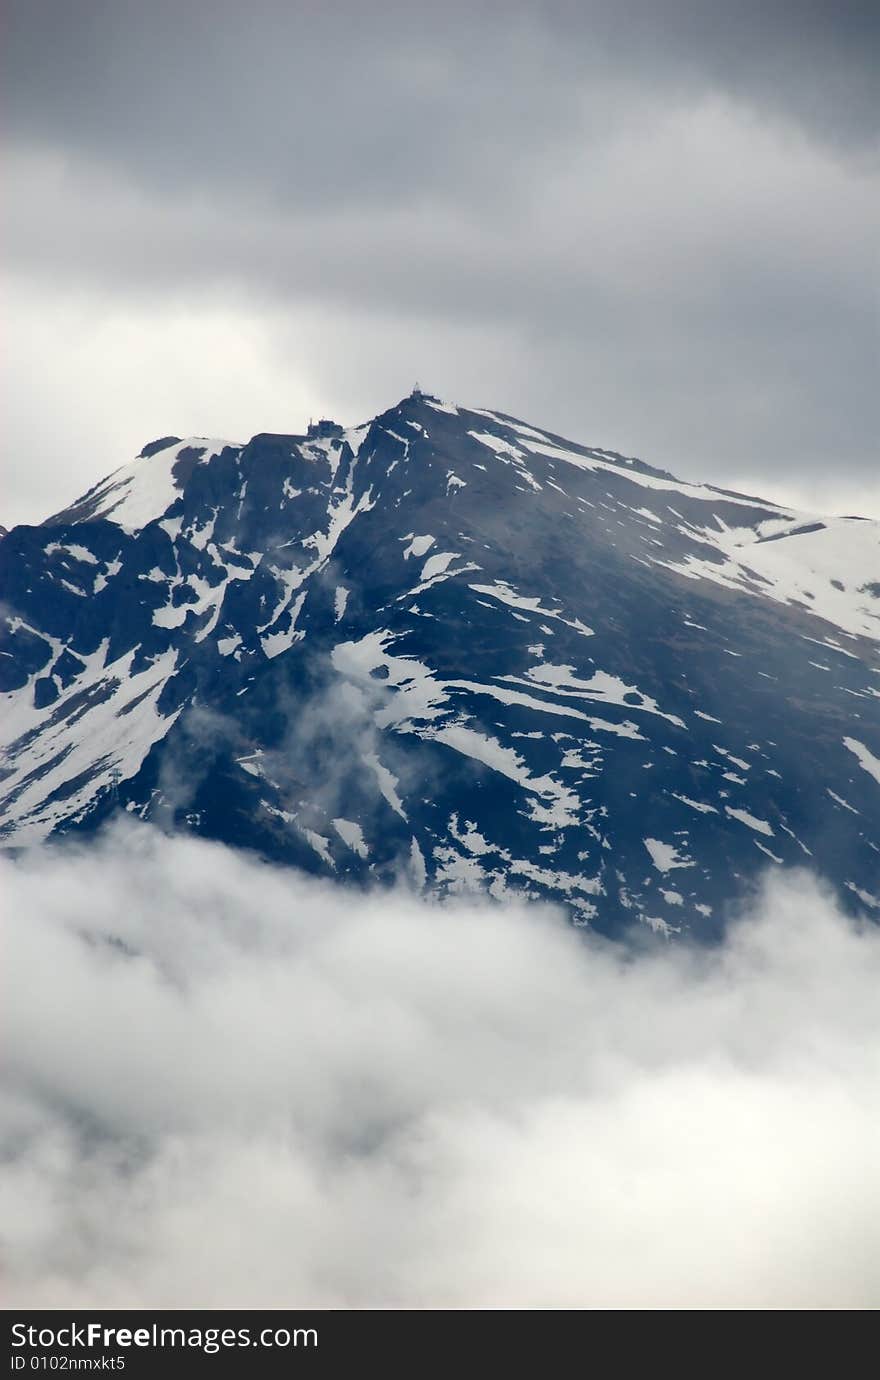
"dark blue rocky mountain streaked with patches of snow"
0,392,880,934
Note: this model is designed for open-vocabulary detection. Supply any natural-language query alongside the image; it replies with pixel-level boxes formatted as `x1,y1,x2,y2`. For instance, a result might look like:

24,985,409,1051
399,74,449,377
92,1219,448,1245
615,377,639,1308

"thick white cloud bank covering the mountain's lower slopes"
0,829,880,1308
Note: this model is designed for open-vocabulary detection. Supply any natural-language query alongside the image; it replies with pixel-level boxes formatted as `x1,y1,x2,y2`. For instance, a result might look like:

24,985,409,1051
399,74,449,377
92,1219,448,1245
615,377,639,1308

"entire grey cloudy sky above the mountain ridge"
0,0,880,524
